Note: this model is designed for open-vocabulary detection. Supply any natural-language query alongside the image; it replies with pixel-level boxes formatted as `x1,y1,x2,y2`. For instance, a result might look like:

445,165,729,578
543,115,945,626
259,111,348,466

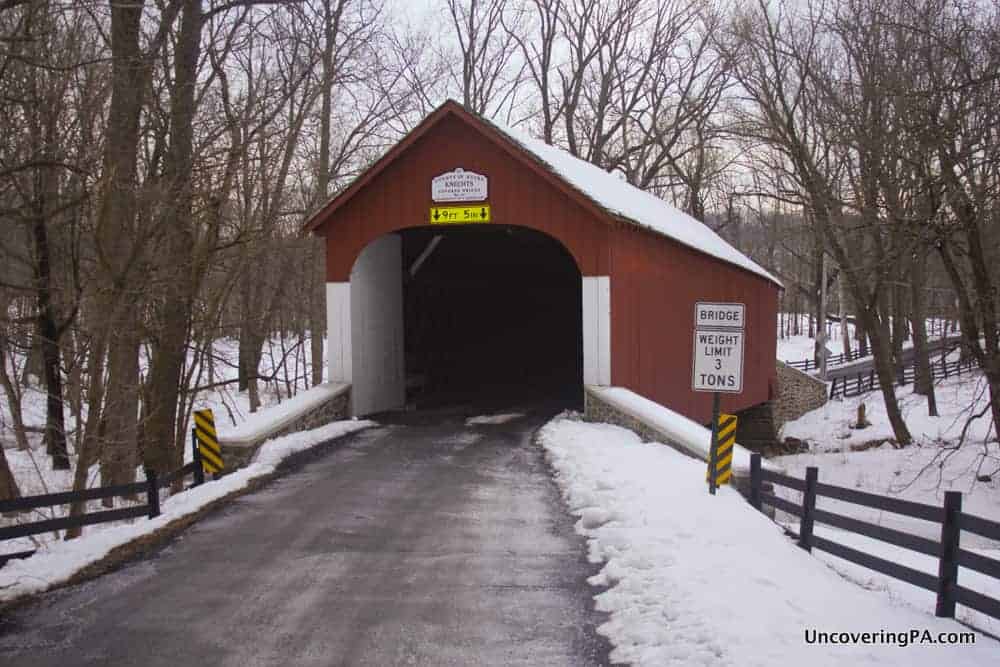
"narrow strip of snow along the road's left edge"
0,420,375,600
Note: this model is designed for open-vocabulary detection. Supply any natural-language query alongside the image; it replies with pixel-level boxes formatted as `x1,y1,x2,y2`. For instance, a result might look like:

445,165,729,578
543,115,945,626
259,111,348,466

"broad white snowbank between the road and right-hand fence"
539,418,1000,667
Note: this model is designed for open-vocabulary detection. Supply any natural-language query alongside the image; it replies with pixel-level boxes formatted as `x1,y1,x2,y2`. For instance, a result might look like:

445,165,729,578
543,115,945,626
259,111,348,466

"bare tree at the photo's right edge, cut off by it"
912,0,1000,444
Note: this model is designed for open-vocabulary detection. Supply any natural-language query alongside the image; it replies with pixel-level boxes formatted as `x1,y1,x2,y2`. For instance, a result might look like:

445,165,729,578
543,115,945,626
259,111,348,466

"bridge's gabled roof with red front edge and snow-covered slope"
304,100,782,287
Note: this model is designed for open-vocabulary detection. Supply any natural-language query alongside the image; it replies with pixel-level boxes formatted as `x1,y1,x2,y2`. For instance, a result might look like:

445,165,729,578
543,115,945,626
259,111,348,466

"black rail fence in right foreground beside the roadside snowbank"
750,454,1000,619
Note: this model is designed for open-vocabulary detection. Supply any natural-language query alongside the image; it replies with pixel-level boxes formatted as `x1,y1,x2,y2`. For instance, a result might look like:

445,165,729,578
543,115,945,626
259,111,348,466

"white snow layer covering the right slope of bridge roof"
483,119,782,287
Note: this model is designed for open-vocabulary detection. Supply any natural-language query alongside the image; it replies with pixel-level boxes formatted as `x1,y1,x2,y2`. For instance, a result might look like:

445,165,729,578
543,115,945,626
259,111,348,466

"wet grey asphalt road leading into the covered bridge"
0,411,609,667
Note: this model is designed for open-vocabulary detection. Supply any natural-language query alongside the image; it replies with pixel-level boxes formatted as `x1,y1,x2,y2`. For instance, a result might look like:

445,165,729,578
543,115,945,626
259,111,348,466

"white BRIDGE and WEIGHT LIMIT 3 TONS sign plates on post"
691,302,745,394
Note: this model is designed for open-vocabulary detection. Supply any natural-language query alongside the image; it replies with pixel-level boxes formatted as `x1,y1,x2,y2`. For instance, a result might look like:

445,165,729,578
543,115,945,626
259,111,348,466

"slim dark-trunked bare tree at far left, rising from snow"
0,2,99,469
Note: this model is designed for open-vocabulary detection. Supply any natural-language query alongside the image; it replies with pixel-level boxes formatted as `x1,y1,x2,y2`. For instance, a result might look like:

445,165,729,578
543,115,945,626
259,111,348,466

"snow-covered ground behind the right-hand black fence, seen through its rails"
771,374,1000,634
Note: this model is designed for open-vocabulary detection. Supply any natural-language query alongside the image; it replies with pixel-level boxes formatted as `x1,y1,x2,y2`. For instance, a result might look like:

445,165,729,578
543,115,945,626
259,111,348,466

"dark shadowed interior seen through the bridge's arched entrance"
401,224,583,408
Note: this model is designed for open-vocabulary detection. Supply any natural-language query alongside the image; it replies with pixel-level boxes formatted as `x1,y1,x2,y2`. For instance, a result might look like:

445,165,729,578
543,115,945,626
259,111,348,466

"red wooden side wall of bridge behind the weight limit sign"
611,225,778,423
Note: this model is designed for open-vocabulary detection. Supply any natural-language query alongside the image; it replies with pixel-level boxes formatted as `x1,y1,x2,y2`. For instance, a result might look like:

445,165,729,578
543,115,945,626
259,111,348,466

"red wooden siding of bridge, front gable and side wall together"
309,103,779,423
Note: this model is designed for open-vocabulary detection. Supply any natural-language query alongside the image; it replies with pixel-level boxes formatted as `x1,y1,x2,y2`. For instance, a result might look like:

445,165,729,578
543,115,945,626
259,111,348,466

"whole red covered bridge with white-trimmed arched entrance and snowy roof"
306,101,781,430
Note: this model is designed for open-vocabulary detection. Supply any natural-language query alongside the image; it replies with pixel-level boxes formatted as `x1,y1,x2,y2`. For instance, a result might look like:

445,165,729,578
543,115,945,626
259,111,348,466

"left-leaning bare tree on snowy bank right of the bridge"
733,2,912,445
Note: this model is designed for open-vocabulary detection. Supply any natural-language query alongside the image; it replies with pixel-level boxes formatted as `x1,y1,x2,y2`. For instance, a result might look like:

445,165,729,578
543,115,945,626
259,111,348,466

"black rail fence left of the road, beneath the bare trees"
0,460,205,567
